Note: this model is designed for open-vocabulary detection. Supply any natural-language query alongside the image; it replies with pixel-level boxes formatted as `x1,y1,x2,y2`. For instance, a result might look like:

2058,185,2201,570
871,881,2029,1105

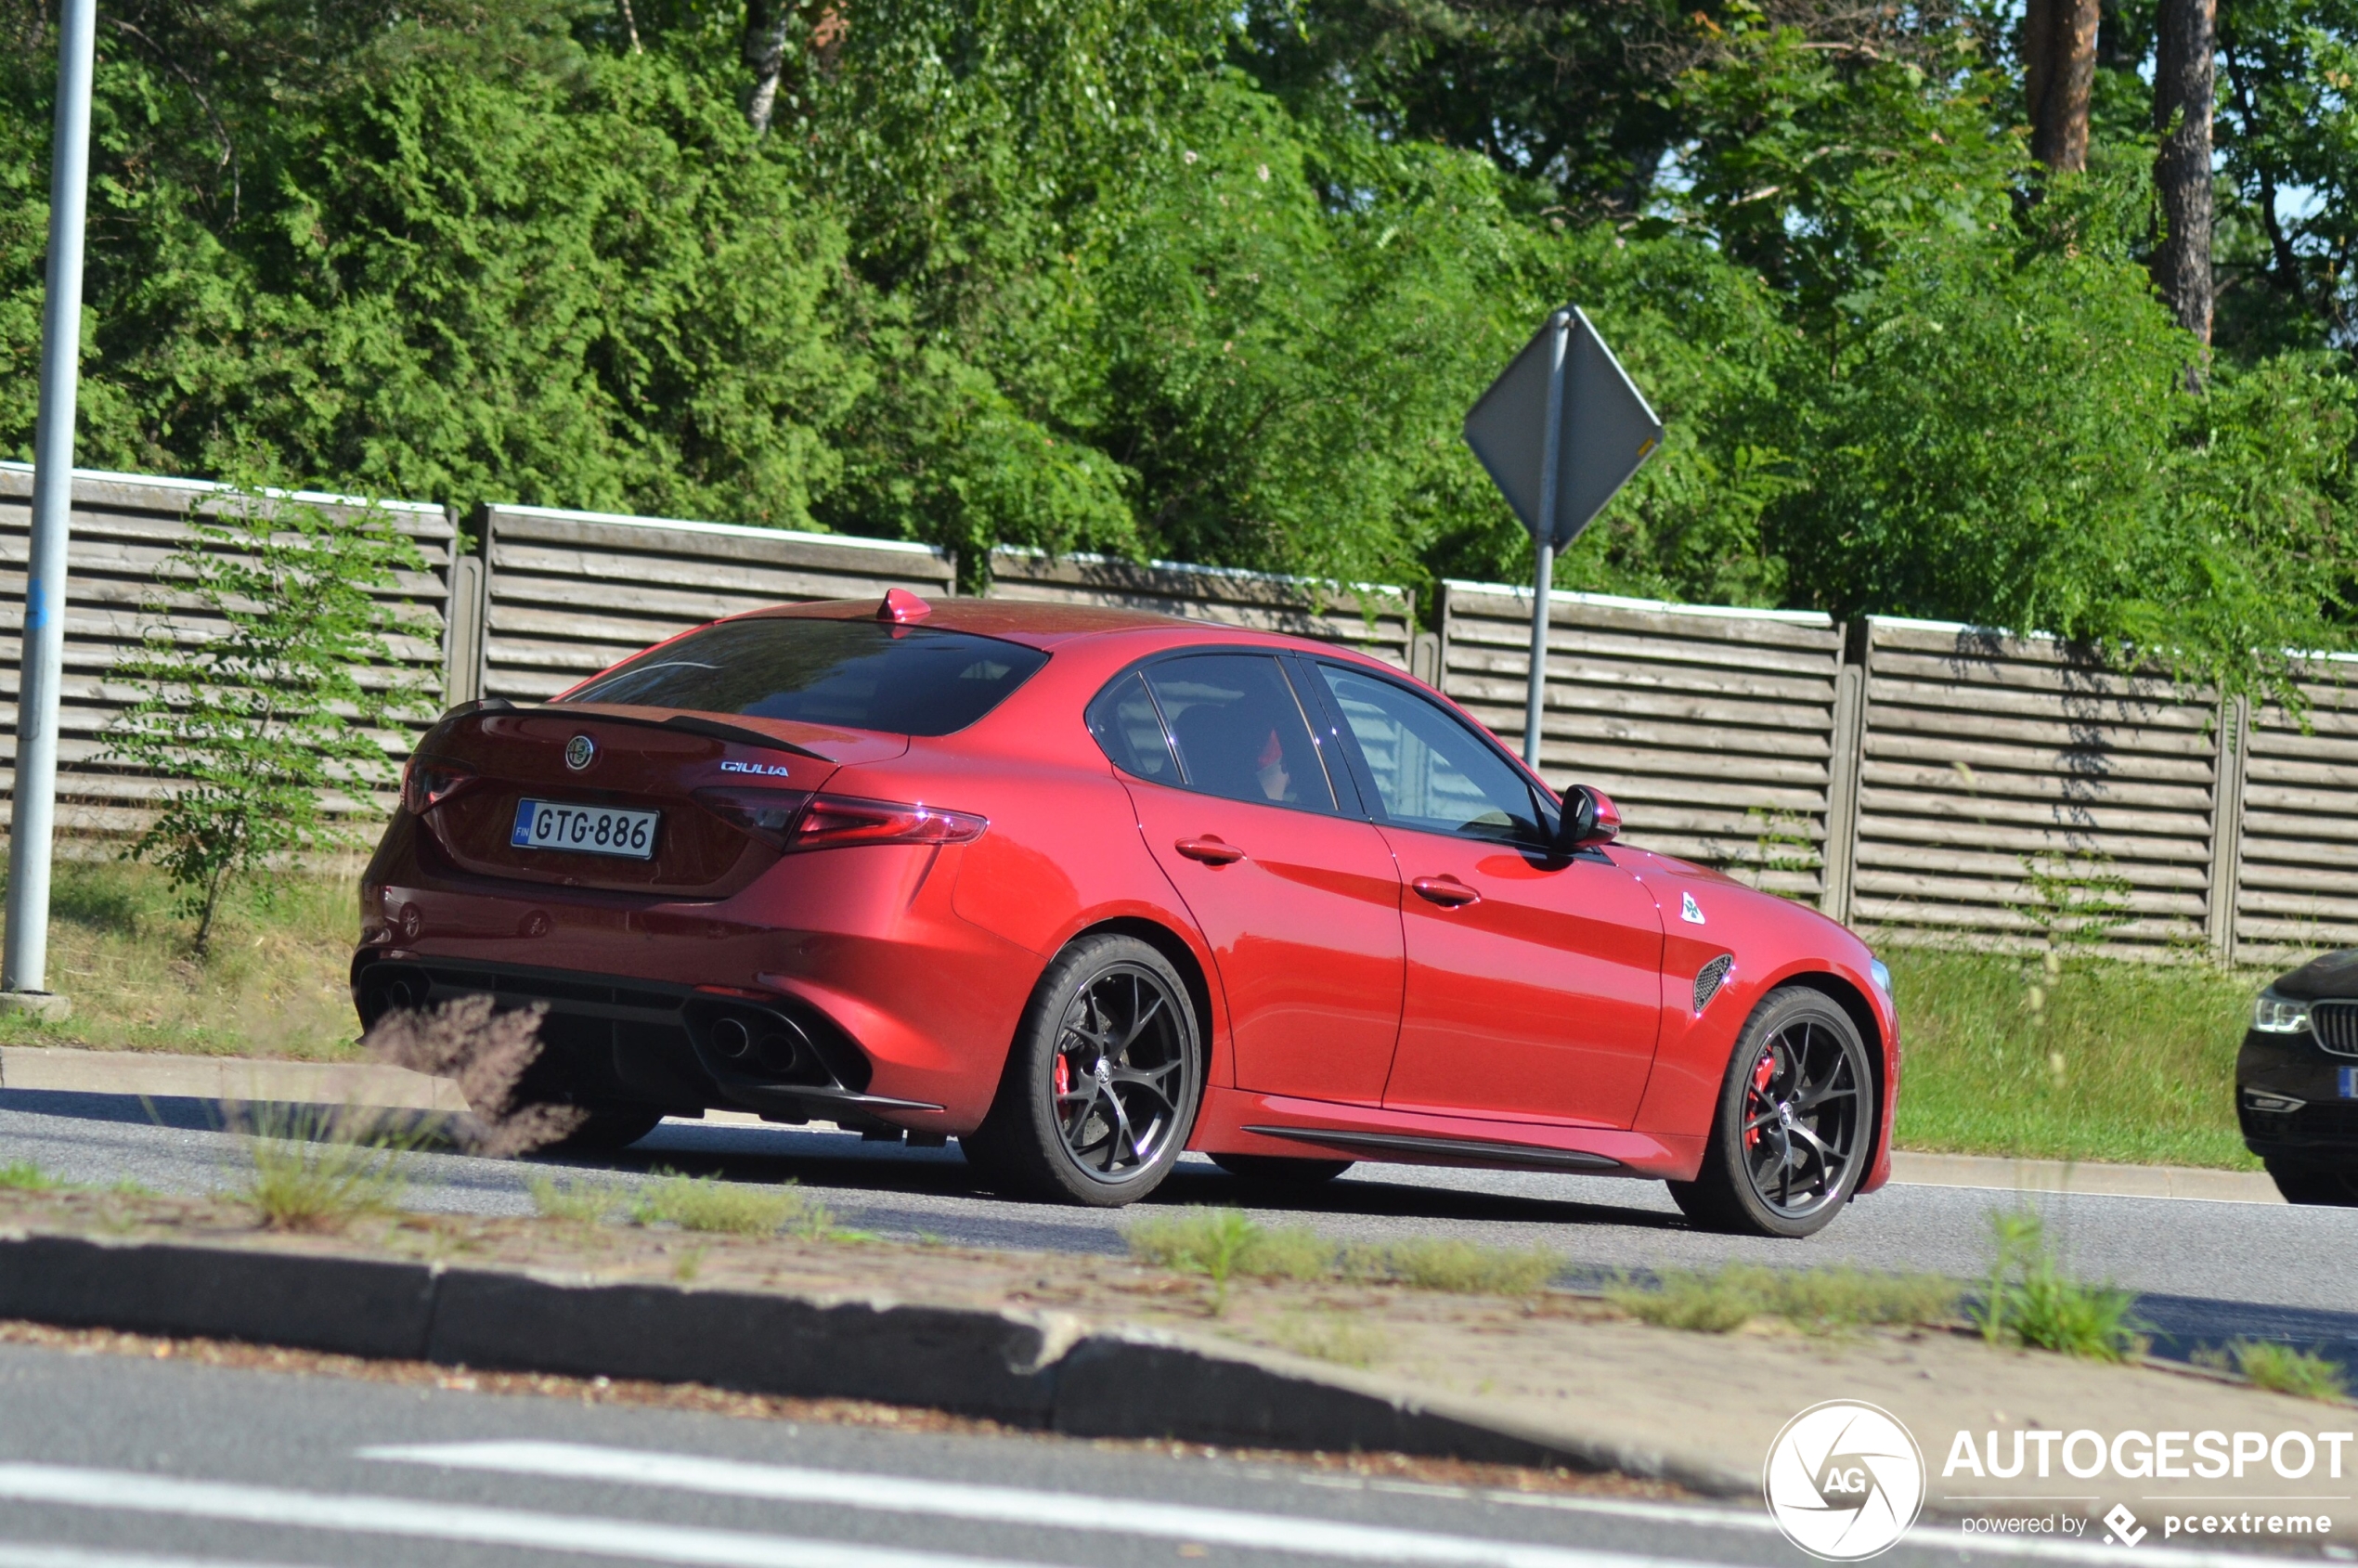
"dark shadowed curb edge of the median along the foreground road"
0,1233,1759,1497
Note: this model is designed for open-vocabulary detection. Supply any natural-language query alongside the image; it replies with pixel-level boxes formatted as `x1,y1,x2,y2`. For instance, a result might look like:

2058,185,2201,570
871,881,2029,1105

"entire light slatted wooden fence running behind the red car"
0,464,2358,962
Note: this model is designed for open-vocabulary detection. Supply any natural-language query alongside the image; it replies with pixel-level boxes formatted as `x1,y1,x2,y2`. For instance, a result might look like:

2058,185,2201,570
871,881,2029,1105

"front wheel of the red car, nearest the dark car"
1669,986,1879,1238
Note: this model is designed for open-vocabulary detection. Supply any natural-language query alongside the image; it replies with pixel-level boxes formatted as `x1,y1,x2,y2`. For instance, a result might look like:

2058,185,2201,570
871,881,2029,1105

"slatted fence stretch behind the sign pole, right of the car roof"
1436,582,2358,962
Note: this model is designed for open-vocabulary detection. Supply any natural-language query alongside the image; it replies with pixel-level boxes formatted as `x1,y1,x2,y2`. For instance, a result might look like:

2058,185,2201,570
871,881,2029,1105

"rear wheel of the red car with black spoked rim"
960,934,1202,1207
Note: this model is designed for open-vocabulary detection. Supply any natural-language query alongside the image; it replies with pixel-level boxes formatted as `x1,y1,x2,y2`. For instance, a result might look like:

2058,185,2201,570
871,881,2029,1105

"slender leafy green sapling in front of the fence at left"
106,490,432,955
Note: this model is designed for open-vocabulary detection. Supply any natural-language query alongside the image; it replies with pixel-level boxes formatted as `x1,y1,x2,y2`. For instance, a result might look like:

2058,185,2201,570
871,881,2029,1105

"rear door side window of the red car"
1146,654,1335,811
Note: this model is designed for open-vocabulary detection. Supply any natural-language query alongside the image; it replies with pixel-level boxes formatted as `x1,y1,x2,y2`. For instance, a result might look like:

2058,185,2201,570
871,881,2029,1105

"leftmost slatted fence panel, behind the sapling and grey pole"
0,462,453,835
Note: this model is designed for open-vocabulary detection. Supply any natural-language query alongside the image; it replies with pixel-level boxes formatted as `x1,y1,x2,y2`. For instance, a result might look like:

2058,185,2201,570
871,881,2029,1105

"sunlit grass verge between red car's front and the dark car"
1884,948,2274,1170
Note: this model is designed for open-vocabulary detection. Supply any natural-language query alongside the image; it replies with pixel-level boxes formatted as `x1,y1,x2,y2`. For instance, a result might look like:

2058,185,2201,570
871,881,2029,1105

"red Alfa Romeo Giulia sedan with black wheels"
351,592,1898,1236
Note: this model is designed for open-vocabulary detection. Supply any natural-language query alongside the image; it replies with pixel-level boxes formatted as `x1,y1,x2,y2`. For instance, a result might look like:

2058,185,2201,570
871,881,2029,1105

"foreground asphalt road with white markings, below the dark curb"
0,1344,2301,1568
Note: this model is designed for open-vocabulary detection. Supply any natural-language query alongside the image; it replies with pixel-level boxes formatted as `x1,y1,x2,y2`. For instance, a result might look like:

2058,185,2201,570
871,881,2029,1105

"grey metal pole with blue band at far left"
0,0,99,1012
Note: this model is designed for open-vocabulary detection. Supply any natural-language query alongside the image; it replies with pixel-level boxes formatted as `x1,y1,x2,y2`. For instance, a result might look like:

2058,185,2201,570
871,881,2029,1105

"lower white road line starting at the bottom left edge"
0,1464,1035,1568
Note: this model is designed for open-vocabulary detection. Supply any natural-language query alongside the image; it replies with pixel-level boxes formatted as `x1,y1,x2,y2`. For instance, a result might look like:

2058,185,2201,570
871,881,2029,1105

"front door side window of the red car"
1318,665,1547,844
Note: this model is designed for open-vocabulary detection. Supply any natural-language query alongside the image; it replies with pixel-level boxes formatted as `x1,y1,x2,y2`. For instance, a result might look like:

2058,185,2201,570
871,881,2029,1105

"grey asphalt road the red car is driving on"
0,1089,2358,1367
